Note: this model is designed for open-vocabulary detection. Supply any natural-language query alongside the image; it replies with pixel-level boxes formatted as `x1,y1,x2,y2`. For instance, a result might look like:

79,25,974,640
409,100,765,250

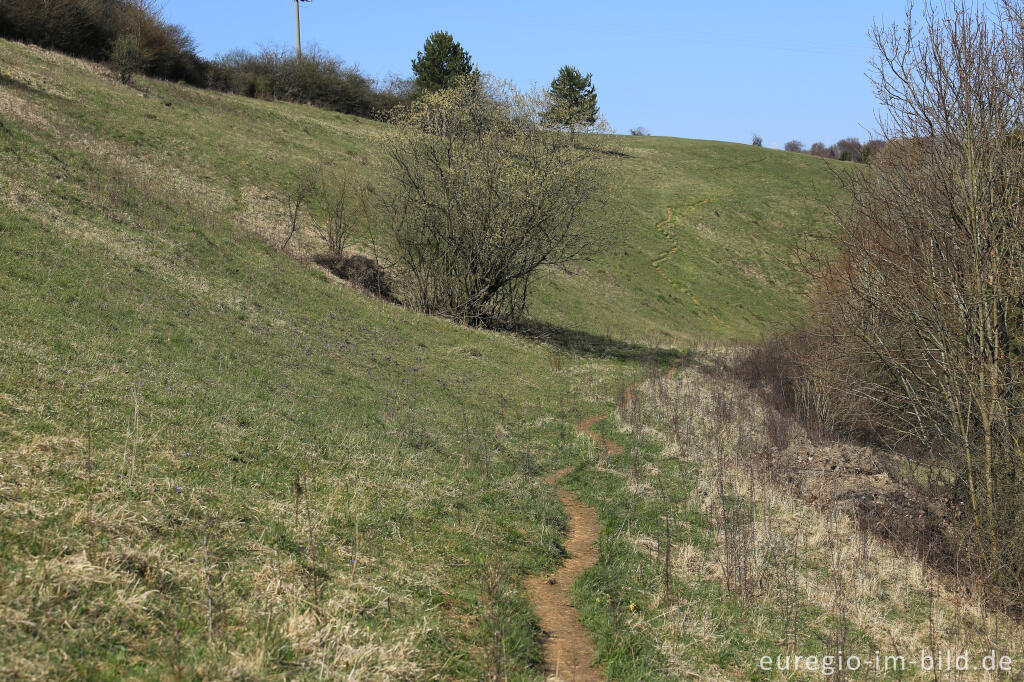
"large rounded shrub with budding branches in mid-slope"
381,78,610,325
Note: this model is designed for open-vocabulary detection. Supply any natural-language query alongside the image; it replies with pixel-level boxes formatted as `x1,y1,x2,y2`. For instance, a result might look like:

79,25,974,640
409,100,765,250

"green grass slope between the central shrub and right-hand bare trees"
535,137,842,340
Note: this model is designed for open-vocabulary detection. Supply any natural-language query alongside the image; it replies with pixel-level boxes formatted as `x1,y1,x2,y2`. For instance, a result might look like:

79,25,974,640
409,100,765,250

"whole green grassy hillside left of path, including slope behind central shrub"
0,41,872,679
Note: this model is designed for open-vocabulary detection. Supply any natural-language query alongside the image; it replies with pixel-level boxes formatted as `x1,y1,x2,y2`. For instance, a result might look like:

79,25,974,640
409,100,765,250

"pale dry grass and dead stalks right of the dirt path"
618,348,1024,679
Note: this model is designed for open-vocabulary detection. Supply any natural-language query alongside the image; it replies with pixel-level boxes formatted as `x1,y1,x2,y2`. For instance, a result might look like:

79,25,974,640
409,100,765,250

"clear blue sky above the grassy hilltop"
164,0,904,146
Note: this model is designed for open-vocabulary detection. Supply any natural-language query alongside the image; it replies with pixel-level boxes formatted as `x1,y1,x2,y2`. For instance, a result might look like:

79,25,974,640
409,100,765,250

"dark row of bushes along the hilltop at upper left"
0,0,412,117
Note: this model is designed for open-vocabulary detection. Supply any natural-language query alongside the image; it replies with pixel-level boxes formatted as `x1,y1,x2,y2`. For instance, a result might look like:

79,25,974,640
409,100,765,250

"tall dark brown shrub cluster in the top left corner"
0,0,206,85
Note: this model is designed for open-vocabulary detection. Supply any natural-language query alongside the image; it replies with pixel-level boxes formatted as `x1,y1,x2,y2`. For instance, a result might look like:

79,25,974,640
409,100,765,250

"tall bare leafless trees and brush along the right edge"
791,0,1024,595
